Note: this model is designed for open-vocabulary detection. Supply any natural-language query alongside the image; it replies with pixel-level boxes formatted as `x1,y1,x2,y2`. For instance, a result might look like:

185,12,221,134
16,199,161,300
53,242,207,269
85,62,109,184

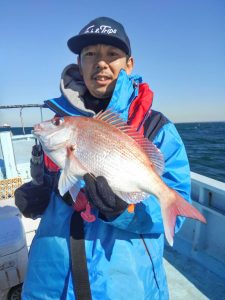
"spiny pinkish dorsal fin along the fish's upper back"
94,110,164,175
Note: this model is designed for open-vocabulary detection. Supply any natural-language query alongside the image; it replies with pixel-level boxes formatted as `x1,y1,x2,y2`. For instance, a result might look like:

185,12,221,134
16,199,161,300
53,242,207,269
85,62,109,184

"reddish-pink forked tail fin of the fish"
161,191,206,246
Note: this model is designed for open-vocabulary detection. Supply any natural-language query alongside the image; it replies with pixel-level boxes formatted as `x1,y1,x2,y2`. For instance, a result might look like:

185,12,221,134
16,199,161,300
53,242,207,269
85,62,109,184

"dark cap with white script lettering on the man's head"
67,17,131,56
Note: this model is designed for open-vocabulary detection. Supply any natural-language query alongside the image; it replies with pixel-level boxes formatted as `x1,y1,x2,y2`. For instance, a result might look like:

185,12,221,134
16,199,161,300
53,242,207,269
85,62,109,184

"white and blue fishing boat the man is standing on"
0,106,225,300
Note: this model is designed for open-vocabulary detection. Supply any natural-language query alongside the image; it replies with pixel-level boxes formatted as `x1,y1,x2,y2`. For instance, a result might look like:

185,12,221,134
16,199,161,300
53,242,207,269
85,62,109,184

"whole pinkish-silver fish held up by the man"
33,110,206,246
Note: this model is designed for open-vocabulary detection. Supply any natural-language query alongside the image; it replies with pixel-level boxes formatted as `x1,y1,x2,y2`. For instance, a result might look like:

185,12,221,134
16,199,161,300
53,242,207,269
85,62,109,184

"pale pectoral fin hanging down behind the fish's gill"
58,146,88,196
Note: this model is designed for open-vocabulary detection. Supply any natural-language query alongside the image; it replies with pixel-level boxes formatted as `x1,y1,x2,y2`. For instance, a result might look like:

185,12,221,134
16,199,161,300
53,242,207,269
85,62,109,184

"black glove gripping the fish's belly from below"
84,174,128,218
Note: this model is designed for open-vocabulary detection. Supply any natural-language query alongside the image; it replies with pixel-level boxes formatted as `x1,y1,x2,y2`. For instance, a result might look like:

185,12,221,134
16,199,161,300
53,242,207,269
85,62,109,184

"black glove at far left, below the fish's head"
15,182,51,219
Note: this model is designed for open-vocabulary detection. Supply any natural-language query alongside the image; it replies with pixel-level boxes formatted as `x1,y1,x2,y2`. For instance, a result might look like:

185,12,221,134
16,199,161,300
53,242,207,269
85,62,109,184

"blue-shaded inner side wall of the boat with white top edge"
174,172,225,278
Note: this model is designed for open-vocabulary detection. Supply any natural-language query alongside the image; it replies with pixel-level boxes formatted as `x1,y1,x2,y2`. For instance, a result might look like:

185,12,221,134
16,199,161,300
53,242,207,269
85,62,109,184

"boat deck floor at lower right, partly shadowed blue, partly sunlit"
164,247,225,300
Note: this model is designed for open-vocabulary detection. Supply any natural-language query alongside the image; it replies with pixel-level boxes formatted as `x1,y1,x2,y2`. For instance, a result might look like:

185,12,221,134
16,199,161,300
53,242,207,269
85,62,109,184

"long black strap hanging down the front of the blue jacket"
70,211,92,300
